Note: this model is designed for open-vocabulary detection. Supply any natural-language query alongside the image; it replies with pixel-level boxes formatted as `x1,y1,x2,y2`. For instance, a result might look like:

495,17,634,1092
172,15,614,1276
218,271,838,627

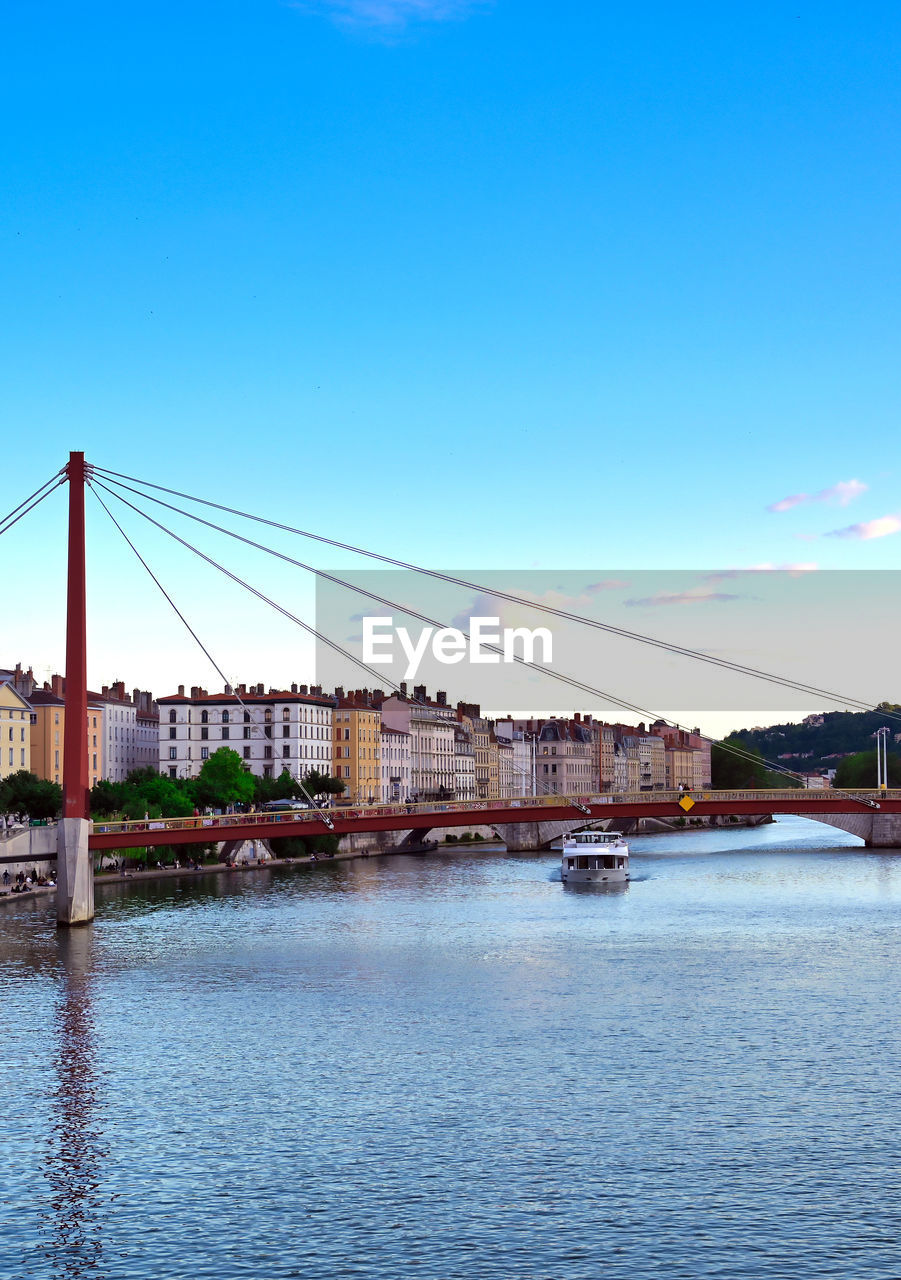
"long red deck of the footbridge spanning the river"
90,788,901,850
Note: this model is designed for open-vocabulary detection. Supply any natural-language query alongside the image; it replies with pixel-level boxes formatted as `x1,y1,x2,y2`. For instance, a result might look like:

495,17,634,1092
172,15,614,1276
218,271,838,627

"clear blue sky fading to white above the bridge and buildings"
0,0,901,721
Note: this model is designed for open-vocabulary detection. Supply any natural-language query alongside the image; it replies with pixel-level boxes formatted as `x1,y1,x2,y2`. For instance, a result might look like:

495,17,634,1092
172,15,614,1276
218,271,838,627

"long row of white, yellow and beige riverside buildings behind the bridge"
0,667,710,803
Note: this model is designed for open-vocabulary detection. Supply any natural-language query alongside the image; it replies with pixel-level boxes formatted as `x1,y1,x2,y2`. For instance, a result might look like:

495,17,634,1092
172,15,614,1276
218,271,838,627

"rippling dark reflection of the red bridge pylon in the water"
42,925,109,1280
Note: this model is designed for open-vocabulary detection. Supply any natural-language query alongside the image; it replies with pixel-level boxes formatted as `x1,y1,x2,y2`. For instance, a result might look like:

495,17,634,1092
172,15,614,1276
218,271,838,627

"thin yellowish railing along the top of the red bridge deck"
93,787,901,841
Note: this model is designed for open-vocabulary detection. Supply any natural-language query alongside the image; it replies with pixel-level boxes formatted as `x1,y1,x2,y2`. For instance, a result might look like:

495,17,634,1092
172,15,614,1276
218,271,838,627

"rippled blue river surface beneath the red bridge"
0,819,901,1280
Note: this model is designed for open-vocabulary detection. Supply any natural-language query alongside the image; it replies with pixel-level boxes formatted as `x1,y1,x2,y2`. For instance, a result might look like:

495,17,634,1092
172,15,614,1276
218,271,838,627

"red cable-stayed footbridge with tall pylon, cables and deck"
0,452,901,924
